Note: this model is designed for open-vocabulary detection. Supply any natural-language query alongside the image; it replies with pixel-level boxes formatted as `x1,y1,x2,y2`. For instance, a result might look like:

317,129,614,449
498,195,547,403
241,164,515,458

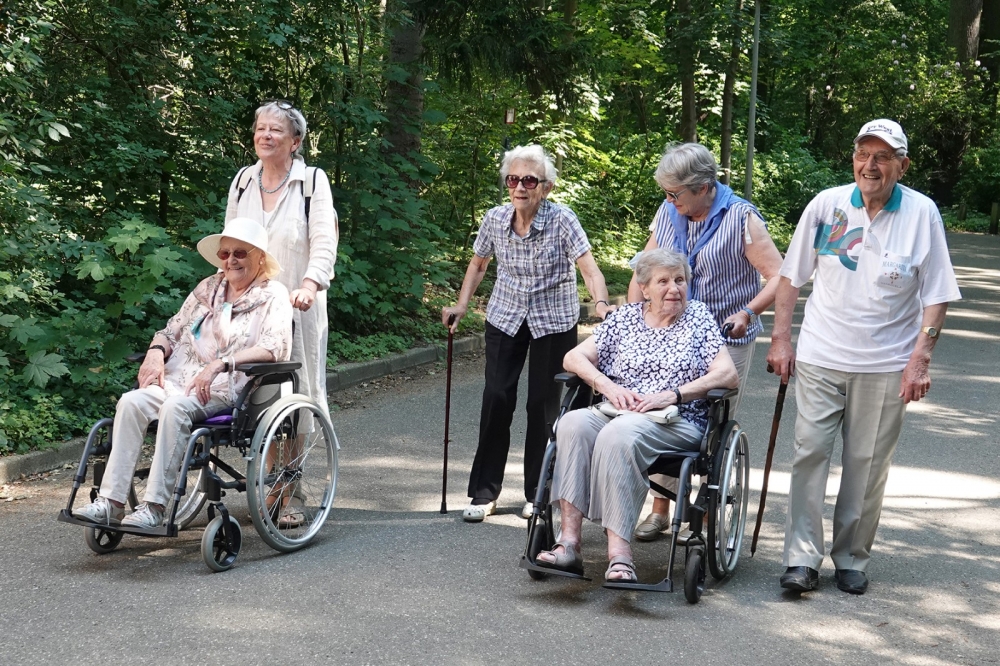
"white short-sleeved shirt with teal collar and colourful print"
780,184,962,372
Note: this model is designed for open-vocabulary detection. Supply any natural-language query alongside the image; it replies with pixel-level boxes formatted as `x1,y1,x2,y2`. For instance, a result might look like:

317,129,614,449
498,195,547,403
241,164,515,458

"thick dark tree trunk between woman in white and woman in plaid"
385,0,425,170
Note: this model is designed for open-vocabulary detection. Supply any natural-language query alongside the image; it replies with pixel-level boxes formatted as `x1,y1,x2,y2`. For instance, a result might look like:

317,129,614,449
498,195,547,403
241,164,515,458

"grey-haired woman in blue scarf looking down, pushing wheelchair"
628,143,781,541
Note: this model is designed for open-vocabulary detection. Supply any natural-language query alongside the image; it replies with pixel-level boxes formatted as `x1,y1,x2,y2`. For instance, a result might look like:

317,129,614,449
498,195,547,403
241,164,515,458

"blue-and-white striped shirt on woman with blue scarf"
649,183,764,346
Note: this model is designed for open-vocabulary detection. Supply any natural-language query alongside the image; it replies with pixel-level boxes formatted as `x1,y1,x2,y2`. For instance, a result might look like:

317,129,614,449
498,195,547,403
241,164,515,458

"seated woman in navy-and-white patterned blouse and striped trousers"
534,249,739,583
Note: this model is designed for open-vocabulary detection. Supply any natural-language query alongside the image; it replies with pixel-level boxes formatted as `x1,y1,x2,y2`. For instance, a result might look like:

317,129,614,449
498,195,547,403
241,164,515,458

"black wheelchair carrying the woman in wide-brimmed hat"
58,354,339,571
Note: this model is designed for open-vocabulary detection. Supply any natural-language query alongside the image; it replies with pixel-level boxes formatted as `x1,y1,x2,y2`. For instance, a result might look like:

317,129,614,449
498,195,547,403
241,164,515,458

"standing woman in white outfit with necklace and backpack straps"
226,100,339,526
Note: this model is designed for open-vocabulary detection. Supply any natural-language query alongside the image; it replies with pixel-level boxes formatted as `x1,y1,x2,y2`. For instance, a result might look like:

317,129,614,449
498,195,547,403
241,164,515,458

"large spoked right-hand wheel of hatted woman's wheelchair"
247,395,337,552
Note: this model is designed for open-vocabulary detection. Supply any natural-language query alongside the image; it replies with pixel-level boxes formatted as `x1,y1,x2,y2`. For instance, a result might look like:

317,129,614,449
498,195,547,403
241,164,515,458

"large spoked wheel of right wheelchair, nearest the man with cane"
708,421,750,580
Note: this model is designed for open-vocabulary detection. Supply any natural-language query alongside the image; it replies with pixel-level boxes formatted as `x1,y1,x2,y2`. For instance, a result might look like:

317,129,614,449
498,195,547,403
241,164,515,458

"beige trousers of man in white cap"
784,362,906,571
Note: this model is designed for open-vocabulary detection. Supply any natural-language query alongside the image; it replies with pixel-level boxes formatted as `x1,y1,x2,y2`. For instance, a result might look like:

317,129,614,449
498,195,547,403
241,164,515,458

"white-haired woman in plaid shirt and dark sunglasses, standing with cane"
441,145,614,522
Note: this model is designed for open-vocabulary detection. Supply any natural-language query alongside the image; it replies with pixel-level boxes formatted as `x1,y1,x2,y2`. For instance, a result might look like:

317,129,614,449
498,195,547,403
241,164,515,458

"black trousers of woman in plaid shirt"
469,322,577,501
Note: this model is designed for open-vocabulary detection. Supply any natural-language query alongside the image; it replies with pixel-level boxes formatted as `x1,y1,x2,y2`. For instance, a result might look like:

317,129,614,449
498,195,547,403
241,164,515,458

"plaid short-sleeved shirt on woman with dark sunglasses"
473,200,590,338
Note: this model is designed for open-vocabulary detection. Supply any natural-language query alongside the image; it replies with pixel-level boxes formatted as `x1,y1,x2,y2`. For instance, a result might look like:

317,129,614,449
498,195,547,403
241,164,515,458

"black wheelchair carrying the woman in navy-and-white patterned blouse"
520,372,750,604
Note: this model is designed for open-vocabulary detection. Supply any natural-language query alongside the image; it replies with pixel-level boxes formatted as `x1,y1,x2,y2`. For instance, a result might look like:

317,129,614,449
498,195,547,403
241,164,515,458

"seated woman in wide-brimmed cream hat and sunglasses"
73,218,292,529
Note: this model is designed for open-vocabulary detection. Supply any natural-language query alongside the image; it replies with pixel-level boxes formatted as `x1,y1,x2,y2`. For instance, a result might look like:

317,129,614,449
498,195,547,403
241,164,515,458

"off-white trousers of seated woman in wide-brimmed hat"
100,386,228,506
